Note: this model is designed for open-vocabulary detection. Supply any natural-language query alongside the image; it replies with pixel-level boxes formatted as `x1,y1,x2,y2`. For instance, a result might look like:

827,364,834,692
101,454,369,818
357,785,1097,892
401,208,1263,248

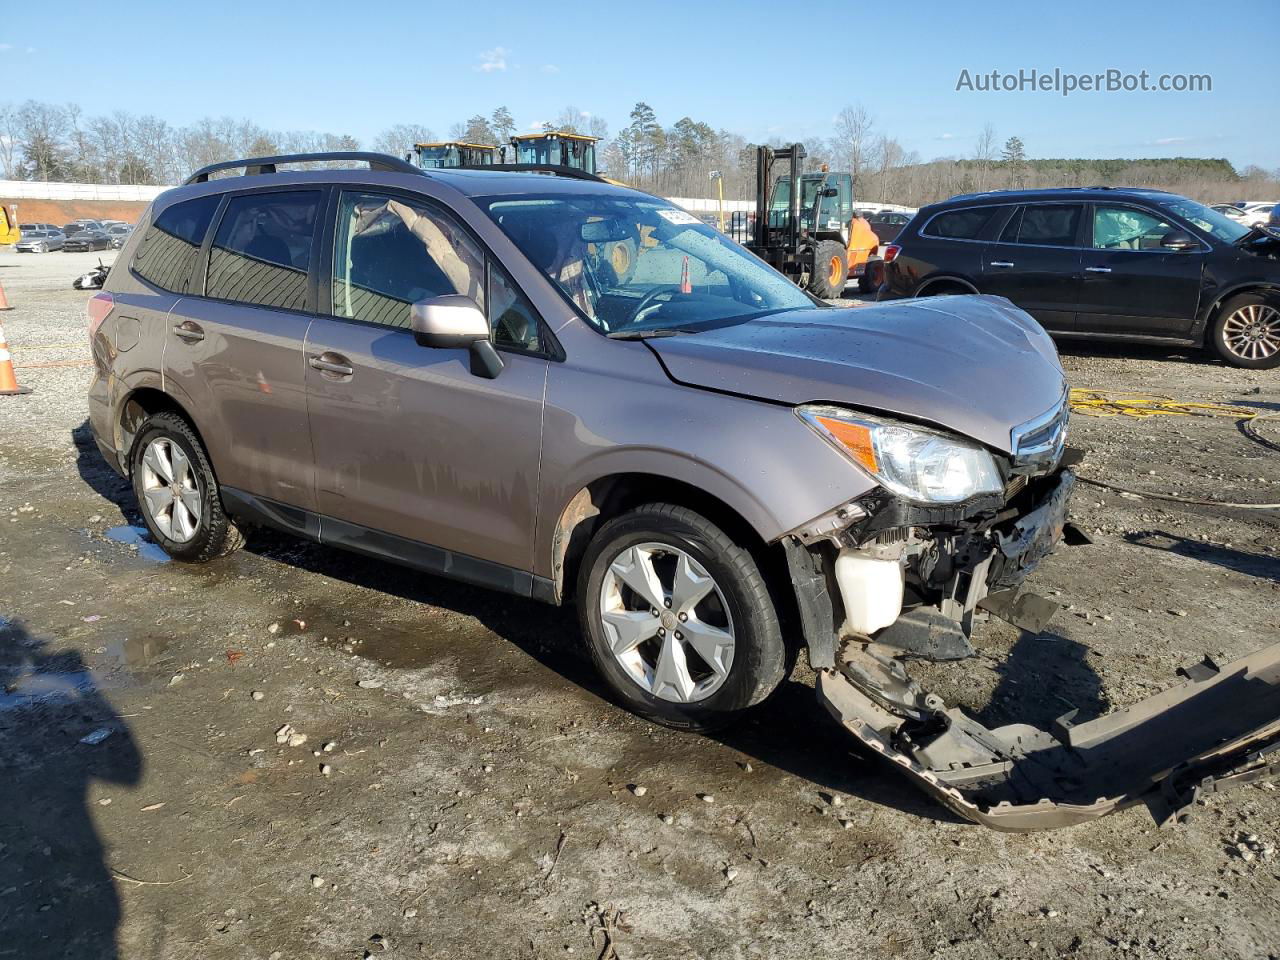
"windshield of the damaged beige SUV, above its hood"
477,195,815,333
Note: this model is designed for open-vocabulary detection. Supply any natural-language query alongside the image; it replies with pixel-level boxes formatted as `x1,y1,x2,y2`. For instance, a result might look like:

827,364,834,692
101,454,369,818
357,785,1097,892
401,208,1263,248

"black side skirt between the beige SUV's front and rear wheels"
219,486,556,603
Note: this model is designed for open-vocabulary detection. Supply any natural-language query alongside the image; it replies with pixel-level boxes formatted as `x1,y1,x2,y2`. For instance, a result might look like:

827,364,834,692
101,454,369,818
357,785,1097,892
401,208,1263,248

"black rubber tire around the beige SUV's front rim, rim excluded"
577,503,787,730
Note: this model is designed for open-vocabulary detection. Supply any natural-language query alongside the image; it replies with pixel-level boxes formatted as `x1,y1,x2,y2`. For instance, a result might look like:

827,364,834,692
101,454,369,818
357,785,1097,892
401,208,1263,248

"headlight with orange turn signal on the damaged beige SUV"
796,404,1004,503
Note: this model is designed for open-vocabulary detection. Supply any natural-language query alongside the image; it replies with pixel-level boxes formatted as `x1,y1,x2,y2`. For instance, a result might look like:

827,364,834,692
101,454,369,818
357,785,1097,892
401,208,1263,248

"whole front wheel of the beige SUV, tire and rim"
577,503,786,730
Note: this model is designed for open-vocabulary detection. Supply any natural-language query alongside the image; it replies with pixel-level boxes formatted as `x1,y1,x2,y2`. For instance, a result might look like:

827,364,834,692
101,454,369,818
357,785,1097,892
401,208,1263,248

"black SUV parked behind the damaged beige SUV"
879,187,1280,369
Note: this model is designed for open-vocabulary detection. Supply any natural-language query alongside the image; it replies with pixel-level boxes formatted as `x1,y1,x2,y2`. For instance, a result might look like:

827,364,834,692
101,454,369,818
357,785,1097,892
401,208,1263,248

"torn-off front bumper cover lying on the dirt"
818,644,1280,831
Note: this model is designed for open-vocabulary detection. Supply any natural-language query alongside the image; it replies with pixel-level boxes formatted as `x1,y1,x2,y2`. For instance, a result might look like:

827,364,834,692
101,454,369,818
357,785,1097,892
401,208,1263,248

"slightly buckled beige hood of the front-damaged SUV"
646,296,1066,453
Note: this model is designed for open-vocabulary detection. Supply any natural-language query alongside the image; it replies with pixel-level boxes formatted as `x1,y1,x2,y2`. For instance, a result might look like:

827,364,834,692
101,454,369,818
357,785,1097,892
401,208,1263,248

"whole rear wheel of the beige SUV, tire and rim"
131,413,244,563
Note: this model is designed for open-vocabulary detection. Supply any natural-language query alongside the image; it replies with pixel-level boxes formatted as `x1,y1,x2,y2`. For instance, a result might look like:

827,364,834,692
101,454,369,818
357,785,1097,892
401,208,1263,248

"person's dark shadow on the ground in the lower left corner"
0,618,142,960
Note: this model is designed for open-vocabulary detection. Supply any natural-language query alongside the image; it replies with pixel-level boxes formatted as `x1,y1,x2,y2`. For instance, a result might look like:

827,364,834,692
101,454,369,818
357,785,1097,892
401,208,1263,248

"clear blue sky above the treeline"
0,0,1280,169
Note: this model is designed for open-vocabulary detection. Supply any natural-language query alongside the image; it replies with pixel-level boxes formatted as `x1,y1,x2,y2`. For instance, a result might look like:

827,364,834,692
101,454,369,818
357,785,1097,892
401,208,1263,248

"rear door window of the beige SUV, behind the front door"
205,191,321,310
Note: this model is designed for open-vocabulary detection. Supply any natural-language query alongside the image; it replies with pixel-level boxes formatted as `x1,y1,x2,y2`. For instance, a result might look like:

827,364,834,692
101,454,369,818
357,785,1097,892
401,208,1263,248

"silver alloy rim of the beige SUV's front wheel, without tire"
599,543,735,703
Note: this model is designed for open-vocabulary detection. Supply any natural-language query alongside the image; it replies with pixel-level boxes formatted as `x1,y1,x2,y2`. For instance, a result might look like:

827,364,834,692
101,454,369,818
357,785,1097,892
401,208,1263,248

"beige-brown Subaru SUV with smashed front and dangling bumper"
88,154,1275,827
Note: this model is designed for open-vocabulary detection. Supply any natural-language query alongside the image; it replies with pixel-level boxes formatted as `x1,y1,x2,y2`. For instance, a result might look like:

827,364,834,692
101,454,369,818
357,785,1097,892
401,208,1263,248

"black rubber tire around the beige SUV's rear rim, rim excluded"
129,413,244,563
